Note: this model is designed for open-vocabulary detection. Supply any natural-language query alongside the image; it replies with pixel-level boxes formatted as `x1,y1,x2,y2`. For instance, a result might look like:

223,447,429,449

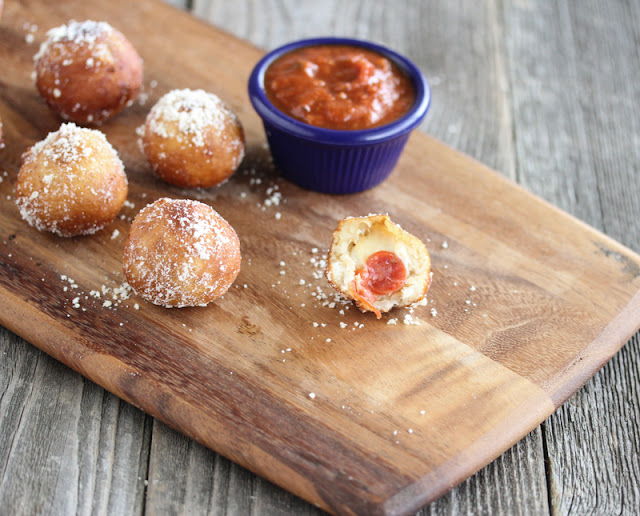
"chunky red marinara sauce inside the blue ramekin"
264,44,416,130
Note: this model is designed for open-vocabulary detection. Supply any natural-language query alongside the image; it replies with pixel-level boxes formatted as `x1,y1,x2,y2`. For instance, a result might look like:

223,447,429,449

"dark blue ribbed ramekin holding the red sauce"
249,38,431,194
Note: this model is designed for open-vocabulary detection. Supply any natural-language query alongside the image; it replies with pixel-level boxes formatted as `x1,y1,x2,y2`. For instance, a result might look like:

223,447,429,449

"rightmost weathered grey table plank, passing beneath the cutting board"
505,1,640,514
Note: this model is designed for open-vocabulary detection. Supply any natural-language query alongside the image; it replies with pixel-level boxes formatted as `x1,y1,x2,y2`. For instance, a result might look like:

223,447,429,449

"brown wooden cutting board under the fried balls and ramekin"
0,0,640,514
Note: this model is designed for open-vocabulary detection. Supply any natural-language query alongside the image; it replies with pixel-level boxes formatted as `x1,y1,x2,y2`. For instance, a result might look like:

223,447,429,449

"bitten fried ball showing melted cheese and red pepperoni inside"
326,215,432,319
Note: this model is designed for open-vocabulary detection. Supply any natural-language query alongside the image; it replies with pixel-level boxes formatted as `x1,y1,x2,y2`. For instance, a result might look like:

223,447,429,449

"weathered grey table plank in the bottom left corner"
0,328,150,514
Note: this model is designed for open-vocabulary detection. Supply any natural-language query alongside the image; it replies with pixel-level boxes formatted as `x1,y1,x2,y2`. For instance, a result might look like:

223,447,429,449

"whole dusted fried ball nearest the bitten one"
123,198,240,308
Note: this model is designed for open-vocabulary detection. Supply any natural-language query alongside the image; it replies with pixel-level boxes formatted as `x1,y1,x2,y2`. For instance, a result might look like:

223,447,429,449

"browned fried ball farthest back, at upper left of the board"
34,20,142,125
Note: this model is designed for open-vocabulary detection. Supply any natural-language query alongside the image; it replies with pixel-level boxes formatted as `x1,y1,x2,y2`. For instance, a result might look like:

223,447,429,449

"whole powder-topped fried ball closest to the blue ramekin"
141,89,245,188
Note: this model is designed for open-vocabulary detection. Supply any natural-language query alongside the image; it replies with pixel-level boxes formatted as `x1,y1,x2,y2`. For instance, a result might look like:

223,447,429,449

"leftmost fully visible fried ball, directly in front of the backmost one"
16,123,128,237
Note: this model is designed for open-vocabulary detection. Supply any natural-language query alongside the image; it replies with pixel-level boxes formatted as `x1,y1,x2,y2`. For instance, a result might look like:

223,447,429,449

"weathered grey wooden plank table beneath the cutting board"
0,0,640,515
